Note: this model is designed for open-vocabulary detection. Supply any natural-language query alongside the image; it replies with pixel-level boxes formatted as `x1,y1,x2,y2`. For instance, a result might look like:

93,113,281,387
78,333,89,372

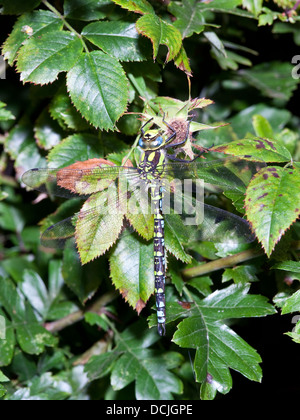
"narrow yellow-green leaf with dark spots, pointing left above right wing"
211,137,292,162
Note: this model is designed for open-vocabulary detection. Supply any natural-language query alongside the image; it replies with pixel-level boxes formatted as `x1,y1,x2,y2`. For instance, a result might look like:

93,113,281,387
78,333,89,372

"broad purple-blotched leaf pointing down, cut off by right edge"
245,166,300,256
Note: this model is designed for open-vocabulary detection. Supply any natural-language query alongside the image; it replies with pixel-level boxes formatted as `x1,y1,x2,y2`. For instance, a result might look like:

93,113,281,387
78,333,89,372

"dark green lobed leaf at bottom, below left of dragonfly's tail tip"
86,324,183,400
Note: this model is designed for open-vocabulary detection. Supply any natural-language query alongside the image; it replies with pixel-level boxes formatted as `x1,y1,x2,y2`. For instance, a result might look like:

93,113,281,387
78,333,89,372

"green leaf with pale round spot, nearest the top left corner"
2,10,63,66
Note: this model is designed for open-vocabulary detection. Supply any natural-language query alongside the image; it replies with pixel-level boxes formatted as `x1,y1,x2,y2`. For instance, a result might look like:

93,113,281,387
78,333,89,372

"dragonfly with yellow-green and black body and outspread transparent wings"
22,115,258,336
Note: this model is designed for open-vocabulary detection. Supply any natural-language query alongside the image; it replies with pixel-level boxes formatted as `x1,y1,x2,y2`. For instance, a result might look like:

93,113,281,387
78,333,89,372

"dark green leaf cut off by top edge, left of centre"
64,0,114,22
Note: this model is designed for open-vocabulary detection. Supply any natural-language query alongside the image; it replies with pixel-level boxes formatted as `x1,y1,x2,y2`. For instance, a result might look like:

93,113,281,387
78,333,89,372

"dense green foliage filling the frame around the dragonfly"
0,0,300,400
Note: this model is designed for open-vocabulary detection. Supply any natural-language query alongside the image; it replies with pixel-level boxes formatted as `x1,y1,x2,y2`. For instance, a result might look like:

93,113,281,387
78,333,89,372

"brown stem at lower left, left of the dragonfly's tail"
44,291,117,333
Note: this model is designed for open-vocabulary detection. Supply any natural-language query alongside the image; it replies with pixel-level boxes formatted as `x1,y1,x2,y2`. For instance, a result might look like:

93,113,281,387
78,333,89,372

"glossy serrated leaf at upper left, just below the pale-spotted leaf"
17,31,83,85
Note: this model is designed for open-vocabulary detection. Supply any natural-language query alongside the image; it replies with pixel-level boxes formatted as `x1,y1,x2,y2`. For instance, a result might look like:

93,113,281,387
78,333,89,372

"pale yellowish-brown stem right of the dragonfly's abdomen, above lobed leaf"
181,249,264,279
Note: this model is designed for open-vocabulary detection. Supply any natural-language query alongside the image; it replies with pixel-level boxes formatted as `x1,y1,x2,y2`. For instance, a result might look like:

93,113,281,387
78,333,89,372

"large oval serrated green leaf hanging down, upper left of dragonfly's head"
67,51,128,130
